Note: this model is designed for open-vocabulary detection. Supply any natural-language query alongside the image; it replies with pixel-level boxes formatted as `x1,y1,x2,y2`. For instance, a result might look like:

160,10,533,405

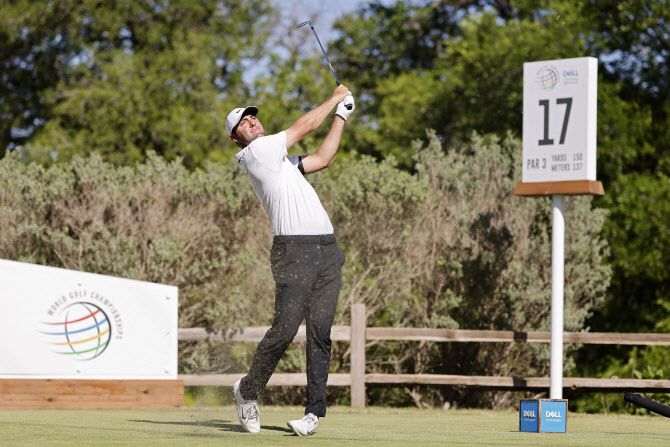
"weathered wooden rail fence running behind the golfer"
179,304,670,407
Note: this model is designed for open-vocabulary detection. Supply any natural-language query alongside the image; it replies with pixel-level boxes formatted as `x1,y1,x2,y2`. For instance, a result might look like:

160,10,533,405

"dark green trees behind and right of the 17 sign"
331,0,670,402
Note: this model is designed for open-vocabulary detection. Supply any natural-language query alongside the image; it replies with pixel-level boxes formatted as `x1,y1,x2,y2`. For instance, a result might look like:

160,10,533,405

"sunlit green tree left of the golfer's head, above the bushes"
0,0,272,166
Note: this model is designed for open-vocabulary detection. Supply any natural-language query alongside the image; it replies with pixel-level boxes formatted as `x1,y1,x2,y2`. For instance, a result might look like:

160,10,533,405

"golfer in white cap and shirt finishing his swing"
226,85,355,436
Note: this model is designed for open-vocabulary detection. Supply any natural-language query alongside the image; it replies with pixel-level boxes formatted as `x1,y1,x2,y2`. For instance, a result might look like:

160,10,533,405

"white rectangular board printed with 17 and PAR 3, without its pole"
522,57,598,183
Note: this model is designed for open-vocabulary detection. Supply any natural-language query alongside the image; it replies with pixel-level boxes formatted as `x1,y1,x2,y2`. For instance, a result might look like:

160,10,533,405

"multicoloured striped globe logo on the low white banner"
40,302,112,360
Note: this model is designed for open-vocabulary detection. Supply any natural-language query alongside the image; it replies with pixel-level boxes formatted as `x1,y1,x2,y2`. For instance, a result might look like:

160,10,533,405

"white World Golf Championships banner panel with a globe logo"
0,260,178,380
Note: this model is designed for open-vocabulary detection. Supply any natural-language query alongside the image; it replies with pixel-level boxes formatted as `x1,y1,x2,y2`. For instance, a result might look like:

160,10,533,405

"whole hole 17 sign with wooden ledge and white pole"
514,57,604,399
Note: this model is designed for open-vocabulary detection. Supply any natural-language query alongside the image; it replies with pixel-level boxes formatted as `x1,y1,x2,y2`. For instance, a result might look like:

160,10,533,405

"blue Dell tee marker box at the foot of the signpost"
519,399,568,433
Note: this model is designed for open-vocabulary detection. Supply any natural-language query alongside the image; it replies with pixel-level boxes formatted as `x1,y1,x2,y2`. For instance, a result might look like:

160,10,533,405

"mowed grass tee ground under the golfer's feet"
0,406,670,447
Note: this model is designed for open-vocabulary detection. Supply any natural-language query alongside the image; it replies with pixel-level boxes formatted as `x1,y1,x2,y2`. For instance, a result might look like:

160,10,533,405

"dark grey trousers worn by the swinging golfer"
240,234,344,417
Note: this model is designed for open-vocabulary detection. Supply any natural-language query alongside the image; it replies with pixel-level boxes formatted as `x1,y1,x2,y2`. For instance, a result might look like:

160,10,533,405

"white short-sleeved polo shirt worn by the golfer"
235,132,333,236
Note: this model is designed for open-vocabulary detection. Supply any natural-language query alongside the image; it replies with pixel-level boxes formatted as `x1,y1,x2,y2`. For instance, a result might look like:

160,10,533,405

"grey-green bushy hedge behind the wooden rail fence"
0,132,611,407
